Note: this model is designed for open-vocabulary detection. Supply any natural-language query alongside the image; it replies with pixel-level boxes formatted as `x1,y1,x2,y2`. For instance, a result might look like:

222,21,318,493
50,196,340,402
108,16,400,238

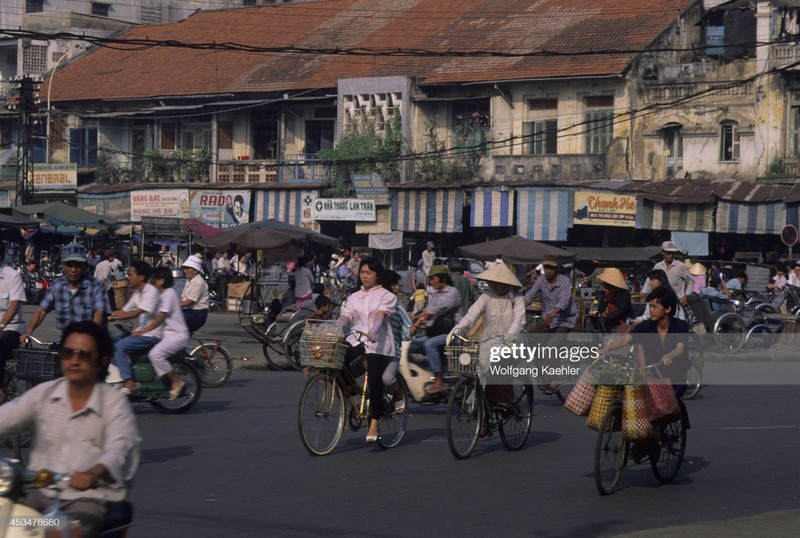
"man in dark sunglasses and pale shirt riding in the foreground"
0,321,142,537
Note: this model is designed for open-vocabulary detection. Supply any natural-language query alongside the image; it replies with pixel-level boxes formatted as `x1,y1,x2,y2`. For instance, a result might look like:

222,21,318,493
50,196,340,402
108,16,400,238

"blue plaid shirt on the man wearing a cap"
39,274,111,331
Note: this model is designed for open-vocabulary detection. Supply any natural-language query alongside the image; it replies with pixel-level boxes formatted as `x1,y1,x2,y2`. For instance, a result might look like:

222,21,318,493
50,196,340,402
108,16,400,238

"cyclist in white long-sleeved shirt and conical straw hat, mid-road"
453,263,525,410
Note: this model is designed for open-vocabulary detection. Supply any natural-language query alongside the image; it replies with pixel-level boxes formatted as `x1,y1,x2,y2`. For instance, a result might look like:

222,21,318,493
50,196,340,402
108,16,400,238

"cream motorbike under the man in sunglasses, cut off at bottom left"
0,458,133,538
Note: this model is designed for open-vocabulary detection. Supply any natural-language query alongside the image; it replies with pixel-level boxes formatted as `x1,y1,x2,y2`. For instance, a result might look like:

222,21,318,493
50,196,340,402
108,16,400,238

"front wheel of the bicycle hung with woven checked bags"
594,403,628,495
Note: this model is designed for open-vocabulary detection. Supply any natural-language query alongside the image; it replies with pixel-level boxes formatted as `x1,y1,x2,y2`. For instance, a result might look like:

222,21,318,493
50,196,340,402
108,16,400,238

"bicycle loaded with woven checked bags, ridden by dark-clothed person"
594,365,688,495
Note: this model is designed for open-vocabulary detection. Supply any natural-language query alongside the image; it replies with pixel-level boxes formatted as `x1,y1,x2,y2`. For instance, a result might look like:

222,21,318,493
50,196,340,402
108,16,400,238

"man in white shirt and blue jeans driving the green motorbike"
108,261,163,395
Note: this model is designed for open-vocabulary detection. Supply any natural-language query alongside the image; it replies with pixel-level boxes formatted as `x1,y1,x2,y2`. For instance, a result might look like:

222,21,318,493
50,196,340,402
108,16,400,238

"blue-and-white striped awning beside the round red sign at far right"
714,200,787,234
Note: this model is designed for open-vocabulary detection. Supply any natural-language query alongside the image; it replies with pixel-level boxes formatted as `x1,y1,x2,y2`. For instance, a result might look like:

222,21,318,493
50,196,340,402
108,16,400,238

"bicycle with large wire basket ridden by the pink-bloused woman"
297,320,409,456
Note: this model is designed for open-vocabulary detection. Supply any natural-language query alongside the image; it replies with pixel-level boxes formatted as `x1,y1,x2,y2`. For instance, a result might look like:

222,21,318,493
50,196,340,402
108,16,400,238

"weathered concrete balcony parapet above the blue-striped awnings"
489,155,608,181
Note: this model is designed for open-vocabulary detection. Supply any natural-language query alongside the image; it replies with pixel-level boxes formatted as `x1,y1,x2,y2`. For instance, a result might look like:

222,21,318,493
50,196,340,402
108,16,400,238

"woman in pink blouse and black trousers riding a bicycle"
339,257,397,445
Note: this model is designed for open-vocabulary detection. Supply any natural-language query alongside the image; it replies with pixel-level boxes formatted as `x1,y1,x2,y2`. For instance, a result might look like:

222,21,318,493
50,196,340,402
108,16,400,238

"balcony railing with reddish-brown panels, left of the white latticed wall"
217,155,327,183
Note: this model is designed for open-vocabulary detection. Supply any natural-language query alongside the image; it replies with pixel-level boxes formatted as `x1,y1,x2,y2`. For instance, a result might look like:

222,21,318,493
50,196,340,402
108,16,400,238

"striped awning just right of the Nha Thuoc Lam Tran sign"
392,189,464,233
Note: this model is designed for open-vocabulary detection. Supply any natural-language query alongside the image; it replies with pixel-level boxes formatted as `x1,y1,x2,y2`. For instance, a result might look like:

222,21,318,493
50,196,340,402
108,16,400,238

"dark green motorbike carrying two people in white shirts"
106,325,205,414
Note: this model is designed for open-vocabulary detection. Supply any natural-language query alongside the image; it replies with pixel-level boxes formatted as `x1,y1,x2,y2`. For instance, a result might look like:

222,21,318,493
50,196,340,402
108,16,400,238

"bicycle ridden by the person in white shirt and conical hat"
446,334,533,459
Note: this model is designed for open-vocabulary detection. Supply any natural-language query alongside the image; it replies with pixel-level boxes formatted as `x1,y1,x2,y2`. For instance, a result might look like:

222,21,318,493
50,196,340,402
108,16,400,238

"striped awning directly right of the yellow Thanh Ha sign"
636,198,714,232
